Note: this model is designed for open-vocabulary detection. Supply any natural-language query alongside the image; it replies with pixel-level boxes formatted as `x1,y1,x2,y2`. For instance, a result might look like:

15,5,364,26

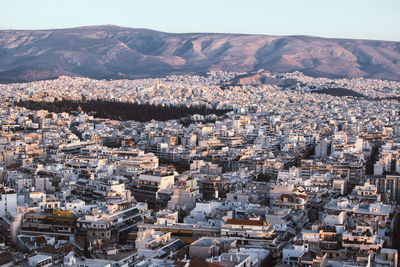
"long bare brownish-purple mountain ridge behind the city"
0,25,400,83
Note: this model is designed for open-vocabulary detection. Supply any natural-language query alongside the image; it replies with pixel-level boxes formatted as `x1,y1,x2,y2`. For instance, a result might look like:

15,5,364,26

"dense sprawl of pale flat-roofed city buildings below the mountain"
0,69,400,267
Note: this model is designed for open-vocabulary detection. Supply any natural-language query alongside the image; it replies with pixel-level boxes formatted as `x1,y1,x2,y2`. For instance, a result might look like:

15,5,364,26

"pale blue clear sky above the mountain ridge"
0,0,400,41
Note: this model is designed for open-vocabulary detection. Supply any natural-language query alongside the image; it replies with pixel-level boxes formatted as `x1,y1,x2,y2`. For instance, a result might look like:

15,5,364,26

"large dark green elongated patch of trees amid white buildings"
16,100,229,122
